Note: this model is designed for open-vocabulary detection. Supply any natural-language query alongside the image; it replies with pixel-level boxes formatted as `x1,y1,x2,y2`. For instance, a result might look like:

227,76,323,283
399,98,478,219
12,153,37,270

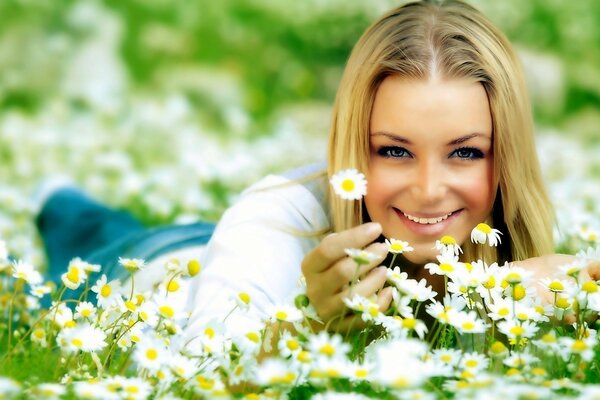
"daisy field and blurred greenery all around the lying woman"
0,0,600,399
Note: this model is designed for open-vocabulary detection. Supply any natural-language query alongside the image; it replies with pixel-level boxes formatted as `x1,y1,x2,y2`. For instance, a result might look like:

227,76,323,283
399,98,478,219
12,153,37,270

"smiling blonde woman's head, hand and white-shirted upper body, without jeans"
41,1,600,336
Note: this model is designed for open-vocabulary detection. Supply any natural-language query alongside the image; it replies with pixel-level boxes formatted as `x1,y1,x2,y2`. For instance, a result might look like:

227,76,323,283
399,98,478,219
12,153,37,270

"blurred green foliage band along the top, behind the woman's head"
0,0,600,136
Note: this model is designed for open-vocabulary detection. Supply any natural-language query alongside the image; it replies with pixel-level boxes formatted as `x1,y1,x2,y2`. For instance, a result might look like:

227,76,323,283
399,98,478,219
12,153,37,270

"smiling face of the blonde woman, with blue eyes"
365,76,496,263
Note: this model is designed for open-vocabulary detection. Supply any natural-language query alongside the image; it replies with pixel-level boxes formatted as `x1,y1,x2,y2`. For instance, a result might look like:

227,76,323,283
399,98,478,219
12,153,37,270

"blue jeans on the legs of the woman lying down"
36,188,215,299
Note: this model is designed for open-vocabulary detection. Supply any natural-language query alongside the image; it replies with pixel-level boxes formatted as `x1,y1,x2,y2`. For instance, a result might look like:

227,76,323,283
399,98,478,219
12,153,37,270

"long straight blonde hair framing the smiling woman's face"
328,1,553,261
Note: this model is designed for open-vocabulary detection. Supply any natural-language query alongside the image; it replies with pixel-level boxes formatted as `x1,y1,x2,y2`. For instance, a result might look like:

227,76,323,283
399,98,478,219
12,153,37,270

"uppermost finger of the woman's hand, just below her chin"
302,222,382,275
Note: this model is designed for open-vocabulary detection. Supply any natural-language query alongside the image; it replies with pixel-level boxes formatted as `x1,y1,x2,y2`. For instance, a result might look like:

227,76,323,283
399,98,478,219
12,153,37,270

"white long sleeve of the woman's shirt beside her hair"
185,165,330,337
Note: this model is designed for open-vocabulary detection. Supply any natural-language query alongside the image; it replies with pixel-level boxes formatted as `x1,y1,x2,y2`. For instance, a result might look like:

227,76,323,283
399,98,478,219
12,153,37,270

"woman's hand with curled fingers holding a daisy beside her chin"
302,222,392,329
